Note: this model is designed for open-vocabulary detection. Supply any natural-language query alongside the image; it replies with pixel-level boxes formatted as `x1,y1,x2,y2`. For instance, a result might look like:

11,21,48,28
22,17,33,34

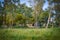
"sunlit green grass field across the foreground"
0,28,60,40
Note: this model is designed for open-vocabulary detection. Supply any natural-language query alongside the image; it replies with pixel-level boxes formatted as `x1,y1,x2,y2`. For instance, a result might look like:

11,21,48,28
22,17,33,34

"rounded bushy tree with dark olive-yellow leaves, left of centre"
15,14,28,27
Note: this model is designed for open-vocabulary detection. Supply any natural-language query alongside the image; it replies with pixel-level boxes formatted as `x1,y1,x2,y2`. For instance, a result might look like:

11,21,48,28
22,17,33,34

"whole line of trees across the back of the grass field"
0,0,60,28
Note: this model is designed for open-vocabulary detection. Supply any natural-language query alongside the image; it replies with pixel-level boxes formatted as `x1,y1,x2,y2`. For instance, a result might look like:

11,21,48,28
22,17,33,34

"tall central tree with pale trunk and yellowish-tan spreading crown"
30,0,44,27
